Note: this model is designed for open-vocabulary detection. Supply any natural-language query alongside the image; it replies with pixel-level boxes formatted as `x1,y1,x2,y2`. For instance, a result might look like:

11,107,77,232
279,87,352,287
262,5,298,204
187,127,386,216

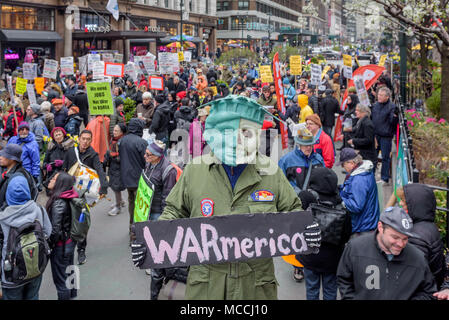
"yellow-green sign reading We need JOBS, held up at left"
86,82,114,115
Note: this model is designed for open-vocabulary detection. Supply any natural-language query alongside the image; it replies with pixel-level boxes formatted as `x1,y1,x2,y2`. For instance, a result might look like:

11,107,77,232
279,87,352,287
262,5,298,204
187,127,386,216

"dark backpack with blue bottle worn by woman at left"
69,192,90,242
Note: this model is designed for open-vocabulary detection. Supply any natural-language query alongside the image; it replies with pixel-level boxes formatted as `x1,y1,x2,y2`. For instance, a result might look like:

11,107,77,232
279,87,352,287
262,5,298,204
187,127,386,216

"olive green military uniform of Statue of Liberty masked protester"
159,154,302,300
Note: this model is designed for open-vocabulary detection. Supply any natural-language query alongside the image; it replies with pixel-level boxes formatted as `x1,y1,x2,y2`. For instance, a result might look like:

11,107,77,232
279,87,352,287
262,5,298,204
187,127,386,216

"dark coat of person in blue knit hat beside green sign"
145,157,177,214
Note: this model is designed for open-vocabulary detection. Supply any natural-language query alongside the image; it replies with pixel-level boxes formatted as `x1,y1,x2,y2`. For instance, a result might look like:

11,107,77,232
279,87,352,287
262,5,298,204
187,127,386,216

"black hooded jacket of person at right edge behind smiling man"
404,183,446,288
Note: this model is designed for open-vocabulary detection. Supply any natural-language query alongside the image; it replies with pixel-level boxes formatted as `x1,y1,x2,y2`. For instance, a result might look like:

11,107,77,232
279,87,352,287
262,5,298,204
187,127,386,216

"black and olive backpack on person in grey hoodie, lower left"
3,207,51,285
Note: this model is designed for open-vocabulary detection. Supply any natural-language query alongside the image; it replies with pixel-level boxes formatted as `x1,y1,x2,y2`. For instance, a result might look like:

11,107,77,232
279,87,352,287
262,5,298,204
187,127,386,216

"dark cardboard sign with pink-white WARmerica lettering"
135,211,313,269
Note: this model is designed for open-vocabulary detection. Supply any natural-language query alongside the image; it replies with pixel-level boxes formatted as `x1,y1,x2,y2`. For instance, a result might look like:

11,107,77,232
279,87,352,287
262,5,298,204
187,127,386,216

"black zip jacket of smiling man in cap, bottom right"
337,231,437,300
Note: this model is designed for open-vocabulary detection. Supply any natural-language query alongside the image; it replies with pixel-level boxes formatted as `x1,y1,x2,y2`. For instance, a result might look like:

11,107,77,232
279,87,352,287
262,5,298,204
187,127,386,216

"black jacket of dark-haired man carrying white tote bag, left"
62,147,108,194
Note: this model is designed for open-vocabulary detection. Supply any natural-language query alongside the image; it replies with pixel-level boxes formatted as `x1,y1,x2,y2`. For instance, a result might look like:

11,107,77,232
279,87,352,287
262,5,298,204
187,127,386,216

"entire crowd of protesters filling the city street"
0,53,449,300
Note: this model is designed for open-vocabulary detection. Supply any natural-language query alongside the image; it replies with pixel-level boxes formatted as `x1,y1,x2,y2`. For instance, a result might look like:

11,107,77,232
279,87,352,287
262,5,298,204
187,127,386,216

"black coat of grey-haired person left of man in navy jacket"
350,116,377,164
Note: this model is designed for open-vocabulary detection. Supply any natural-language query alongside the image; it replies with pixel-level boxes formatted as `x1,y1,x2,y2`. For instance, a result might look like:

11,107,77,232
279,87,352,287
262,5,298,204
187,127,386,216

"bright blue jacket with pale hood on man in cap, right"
340,160,380,233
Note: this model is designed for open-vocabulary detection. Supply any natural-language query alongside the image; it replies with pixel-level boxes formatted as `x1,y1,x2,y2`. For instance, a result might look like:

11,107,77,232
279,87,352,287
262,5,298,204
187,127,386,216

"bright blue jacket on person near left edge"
8,131,41,177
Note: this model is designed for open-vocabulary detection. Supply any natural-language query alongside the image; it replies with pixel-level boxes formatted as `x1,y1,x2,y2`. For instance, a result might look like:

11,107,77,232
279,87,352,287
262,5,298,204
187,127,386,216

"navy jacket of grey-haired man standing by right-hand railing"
371,100,398,138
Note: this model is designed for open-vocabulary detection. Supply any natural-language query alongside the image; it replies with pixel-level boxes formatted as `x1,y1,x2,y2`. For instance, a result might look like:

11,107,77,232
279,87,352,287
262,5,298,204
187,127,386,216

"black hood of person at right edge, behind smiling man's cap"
404,183,437,223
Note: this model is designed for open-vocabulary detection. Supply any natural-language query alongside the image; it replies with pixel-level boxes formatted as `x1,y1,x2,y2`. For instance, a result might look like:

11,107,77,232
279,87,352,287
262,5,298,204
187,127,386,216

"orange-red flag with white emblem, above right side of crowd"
334,64,385,141
